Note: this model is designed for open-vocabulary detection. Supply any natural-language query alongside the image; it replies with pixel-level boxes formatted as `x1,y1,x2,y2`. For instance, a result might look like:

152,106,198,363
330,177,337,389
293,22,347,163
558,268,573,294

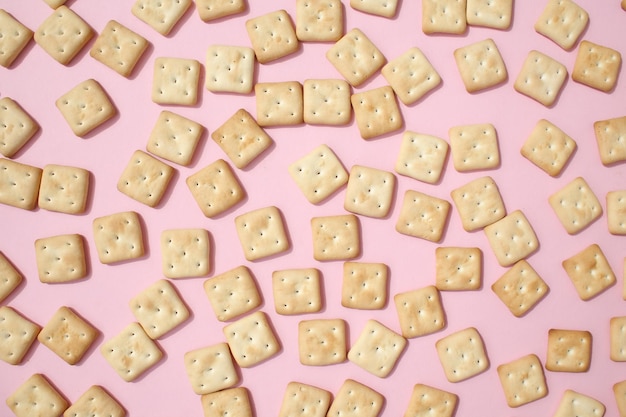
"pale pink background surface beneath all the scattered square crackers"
0,0,626,417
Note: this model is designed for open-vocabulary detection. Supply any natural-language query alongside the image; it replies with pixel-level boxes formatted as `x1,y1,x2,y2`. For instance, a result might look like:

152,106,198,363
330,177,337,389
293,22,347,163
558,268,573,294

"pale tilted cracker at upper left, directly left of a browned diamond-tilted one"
146,110,205,166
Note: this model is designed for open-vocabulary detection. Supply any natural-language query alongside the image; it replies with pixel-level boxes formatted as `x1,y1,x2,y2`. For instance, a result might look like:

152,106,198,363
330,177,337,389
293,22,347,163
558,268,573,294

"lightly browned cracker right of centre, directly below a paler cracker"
396,190,450,242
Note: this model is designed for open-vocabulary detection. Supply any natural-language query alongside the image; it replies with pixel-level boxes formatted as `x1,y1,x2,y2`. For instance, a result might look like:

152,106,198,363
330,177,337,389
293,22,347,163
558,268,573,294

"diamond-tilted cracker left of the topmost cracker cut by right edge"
520,119,578,177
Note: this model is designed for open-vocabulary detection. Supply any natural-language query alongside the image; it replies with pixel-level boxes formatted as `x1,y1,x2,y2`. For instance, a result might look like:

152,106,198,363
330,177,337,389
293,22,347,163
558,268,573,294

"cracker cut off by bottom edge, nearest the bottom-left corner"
6,374,70,417
